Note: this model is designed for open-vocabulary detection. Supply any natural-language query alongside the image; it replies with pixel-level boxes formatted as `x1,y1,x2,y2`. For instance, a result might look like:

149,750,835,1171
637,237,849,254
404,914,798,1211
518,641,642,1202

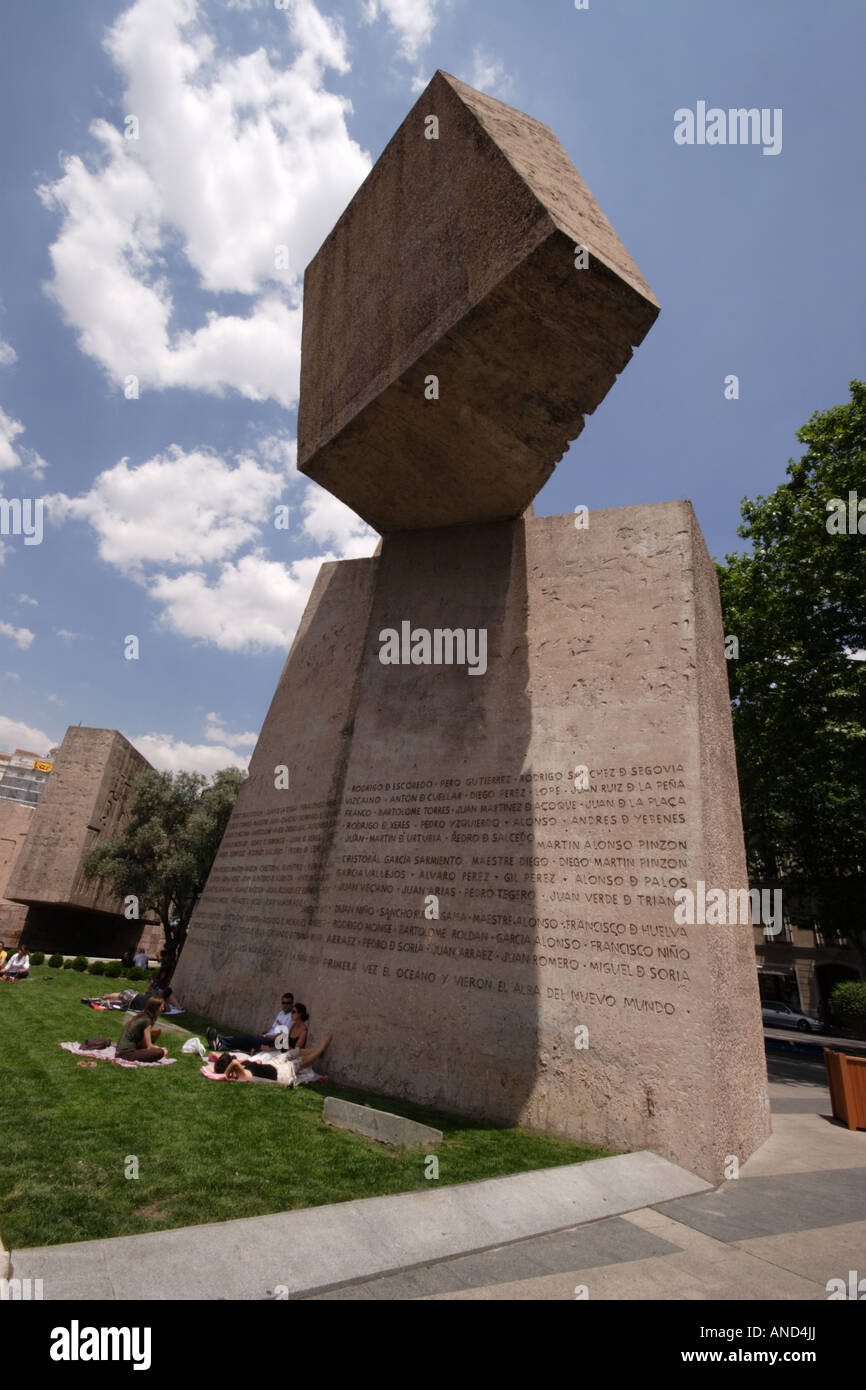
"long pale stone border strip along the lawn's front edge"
13,1151,710,1301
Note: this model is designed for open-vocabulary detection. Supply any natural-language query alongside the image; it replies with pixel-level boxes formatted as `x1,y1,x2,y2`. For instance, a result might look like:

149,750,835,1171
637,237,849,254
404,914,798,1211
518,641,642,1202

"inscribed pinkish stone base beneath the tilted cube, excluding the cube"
175,502,769,1182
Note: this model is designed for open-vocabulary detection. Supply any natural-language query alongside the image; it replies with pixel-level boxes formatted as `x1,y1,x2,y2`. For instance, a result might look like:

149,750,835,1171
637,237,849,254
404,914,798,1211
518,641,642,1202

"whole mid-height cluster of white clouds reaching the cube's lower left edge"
44,434,378,650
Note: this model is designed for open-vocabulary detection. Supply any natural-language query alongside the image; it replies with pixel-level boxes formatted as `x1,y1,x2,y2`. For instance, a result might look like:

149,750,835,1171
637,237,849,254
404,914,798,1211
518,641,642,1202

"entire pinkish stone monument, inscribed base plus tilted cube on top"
177,72,769,1180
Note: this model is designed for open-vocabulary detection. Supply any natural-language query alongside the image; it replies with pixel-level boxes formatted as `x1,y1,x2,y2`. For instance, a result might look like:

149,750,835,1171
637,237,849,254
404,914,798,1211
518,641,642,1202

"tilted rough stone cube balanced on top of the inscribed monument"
297,72,659,532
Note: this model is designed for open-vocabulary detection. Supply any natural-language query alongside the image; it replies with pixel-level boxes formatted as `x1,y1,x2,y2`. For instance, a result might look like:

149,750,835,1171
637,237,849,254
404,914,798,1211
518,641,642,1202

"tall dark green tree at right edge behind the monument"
717,381,866,935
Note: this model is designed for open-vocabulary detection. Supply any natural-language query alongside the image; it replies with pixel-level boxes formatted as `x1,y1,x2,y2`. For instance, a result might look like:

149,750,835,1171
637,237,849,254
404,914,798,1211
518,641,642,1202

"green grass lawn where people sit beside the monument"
0,966,614,1248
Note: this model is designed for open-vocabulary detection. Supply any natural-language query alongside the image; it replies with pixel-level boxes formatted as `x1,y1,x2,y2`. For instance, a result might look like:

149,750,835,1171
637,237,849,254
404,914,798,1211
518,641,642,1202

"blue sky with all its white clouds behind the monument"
0,0,866,773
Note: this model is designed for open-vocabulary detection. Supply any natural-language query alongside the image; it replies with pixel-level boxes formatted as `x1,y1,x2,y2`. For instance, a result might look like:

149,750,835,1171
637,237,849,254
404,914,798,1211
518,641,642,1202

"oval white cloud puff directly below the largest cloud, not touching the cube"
44,445,285,577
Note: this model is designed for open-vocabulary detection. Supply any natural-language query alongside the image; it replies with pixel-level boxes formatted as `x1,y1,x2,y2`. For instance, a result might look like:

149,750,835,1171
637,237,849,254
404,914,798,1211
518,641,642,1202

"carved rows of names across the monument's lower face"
191,755,699,1017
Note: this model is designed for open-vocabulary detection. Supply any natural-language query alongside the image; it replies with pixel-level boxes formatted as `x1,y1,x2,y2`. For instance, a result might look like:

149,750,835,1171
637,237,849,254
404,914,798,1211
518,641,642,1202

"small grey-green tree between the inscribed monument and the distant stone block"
85,767,245,969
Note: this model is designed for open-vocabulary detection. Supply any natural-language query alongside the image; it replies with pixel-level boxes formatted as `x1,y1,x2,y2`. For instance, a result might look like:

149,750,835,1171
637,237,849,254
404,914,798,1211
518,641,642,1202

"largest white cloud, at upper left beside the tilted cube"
39,0,370,406
